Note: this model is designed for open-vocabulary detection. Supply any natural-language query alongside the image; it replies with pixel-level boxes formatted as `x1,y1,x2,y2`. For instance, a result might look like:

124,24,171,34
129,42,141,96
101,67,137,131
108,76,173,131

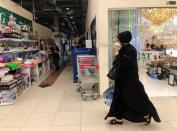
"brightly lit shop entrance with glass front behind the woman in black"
109,8,177,96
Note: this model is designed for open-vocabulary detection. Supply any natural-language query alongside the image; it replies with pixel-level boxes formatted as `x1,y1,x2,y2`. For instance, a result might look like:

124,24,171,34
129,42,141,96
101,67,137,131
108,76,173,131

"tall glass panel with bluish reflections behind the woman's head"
109,9,140,68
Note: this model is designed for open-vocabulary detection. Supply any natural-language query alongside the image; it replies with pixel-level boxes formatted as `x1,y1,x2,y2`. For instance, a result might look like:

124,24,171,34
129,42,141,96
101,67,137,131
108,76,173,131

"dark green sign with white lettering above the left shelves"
0,7,32,29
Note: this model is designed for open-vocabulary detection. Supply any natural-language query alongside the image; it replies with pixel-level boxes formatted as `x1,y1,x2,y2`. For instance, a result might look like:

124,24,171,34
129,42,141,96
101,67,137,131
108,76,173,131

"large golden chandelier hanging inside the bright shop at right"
142,8,177,25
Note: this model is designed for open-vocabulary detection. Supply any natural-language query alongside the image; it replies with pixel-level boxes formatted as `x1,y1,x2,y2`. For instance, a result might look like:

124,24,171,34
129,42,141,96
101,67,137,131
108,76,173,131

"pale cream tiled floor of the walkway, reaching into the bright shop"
0,67,177,131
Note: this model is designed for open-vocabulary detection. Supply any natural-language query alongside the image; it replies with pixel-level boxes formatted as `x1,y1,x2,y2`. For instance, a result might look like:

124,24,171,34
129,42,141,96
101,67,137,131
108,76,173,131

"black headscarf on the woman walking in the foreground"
117,31,132,44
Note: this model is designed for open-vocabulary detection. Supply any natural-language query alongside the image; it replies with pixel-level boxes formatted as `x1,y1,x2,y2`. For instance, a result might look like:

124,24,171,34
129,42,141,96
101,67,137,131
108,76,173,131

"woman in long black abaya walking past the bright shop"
105,31,161,125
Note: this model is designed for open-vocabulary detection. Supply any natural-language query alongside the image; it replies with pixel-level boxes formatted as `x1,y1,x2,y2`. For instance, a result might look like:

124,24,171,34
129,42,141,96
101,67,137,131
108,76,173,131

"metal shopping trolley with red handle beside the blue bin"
77,55,99,101
